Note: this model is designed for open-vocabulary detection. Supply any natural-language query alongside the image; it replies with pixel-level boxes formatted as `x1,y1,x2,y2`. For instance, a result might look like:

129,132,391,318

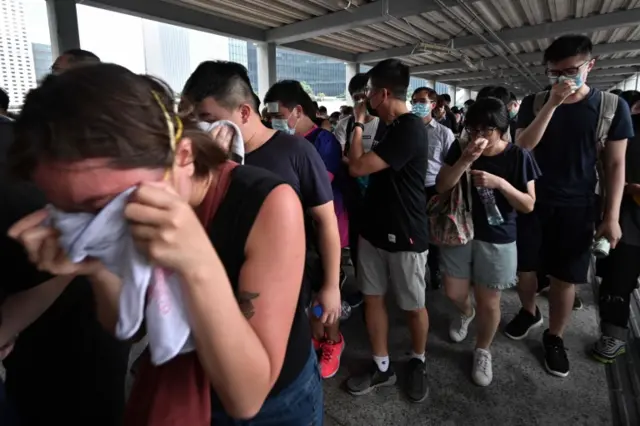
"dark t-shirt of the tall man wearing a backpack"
517,89,633,206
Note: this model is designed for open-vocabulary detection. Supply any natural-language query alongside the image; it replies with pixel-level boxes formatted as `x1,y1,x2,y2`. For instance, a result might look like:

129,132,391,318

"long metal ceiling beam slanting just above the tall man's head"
357,9,640,63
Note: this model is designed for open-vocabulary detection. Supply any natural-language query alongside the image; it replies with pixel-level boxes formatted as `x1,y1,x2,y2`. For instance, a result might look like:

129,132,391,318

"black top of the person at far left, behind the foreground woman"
0,178,129,426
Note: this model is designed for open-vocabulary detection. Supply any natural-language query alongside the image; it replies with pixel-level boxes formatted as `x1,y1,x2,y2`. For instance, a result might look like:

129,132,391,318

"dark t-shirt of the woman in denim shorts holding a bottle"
445,141,540,244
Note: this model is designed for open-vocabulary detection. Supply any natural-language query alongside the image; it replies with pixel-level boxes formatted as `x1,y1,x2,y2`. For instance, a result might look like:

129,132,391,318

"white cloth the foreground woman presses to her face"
48,187,195,365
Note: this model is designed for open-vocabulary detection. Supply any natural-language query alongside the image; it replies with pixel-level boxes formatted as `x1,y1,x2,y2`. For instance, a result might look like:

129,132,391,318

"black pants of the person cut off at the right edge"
599,243,640,340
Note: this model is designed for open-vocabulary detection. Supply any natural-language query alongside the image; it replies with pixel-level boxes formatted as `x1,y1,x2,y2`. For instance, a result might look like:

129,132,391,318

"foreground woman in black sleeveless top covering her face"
10,64,322,425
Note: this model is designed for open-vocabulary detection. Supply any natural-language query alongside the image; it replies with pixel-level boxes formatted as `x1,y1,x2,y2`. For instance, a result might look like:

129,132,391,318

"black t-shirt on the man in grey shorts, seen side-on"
361,113,429,252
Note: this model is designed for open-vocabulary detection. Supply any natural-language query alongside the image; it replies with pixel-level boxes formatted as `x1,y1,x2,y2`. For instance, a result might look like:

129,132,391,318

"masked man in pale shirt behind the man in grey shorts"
411,87,455,289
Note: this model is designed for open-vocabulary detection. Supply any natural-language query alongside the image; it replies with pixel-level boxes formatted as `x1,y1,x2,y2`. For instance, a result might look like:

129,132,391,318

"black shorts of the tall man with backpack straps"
517,204,596,284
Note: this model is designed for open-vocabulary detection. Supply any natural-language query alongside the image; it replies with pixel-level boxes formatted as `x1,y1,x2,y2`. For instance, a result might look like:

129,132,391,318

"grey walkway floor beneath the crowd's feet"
325,272,612,426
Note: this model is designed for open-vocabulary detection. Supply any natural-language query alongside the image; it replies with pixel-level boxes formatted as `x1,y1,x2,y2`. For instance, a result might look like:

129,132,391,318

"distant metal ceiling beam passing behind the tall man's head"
430,62,640,82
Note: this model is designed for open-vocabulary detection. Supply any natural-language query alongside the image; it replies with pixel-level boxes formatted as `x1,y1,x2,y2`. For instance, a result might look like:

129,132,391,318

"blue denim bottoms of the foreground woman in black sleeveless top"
211,350,324,426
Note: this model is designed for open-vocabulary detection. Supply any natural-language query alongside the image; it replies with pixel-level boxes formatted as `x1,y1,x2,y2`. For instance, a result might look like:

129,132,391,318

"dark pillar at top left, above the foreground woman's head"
47,0,80,60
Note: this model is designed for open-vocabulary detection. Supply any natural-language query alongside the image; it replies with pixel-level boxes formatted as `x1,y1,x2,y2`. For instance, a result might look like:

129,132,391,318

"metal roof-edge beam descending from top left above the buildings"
78,0,355,62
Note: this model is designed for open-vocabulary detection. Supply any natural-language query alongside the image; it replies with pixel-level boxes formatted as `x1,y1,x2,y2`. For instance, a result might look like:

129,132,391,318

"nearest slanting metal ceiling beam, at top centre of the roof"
266,0,456,44
